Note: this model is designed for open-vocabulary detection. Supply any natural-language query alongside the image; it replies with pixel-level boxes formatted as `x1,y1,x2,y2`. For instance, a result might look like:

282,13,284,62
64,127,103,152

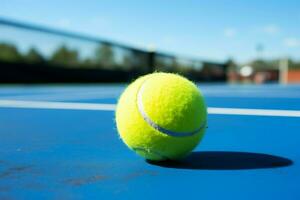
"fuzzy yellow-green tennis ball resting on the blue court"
116,73,207,161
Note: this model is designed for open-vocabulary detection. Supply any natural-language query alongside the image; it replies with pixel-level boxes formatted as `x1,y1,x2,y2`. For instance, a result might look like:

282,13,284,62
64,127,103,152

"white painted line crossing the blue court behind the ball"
0,100,300,117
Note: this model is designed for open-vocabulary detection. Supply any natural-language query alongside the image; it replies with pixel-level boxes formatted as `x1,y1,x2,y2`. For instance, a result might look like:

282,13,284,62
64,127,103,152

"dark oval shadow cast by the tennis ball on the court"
147,151,293,170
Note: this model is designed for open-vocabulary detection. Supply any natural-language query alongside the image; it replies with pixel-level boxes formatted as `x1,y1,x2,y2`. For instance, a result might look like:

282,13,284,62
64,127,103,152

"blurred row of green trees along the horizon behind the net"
0,42,300,72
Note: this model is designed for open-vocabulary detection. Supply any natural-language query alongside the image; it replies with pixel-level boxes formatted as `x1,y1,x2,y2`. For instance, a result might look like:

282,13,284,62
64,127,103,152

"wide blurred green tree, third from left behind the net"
50,45,79,66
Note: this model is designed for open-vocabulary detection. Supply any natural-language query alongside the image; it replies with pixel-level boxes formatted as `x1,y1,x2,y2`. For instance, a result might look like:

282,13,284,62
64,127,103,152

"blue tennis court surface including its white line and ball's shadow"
0,85,300,200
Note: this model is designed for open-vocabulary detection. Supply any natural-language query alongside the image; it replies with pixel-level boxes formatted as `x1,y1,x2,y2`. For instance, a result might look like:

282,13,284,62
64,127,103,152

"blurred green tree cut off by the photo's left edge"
0,43,22,62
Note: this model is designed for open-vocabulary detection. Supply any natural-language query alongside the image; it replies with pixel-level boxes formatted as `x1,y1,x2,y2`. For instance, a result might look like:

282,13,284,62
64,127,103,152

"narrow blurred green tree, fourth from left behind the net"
95,44,115,69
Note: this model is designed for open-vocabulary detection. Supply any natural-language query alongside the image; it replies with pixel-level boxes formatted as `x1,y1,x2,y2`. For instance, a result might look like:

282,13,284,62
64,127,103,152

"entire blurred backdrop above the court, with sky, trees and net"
0,0,300,84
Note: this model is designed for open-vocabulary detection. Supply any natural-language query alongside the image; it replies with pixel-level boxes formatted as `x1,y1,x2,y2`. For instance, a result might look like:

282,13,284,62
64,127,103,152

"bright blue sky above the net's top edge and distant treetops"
0,0,300,62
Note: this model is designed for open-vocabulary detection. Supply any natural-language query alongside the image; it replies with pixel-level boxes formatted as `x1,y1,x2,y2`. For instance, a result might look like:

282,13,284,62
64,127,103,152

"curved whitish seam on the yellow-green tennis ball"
136,78,206,137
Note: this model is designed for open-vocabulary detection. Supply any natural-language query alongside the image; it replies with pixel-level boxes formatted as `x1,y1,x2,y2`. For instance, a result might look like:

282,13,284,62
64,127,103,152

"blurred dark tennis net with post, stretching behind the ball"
0,19,227,83
